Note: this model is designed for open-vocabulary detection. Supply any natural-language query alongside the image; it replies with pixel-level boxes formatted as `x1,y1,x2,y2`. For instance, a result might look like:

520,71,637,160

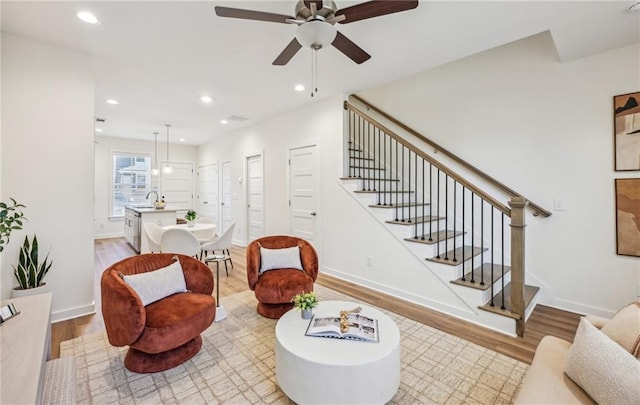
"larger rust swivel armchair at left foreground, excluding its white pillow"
101,253,216,373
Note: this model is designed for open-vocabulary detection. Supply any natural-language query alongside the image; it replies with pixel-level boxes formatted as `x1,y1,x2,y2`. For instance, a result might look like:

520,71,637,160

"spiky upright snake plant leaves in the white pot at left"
13,235,52,296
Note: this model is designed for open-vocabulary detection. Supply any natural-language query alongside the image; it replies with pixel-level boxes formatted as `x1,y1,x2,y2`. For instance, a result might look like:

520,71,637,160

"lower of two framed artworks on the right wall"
616,179,640,257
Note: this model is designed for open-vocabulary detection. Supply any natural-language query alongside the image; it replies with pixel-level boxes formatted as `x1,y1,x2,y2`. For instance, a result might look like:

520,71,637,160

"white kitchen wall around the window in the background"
93,134,198,238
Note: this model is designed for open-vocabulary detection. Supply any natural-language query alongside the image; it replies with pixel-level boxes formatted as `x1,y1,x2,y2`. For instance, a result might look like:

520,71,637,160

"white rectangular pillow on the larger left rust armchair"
121,258,187,306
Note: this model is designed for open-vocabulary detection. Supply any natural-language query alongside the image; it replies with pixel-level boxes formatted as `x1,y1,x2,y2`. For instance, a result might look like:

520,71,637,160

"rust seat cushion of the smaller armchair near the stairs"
255,269,313,304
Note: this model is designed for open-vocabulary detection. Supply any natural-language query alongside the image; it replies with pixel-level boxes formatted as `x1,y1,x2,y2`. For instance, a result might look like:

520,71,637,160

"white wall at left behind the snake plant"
0,34,94,320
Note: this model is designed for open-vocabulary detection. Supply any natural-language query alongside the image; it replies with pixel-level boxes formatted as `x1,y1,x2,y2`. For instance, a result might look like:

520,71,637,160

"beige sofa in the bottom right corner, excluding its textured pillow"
514,302,640,405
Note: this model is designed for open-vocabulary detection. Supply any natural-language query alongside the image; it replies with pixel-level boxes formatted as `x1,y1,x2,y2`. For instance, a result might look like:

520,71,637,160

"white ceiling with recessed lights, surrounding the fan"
1,0,640,145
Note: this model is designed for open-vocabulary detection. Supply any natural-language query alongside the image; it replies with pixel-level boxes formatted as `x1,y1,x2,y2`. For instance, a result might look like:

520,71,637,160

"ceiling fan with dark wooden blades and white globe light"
215,0,418,66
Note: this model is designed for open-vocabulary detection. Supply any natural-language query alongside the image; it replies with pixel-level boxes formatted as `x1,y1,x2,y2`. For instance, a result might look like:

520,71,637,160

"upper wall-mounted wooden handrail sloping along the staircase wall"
344,94,551,217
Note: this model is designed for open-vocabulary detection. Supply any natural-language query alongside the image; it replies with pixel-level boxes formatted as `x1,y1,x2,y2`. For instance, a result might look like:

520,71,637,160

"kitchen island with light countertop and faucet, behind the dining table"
124,205,186,254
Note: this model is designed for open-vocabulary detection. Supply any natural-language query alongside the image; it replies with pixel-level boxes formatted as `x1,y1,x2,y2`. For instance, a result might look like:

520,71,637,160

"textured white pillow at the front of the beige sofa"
565,319,640,405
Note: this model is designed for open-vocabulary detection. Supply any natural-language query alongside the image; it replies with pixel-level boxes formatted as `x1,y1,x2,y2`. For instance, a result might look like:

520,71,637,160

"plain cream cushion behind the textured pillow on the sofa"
600,301,640,359
